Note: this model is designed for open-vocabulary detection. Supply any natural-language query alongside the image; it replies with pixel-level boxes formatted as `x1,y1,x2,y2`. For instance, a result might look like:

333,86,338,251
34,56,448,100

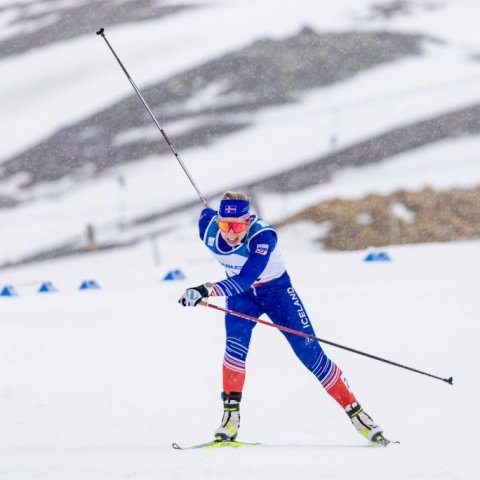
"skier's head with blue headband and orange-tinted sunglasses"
217,192,250,247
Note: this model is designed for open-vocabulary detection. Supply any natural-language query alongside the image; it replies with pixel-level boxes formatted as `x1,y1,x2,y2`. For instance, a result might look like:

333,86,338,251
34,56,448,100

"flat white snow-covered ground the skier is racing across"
0,229,480,480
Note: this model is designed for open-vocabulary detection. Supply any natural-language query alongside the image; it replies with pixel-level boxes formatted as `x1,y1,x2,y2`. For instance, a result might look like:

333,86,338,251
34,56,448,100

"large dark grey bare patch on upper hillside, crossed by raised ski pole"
0,28,425,188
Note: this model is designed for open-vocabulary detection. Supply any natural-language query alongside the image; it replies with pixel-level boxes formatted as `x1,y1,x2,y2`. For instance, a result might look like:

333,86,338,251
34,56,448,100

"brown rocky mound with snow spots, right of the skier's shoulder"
278,187,480,250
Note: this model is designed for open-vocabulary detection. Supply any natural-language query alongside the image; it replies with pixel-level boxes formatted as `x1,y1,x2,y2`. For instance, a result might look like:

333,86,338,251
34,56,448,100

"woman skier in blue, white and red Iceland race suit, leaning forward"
179,192,388,445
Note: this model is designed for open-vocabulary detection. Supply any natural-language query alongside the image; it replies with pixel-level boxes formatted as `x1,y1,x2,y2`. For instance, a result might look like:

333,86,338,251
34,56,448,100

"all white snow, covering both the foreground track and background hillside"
0,0,480,480
